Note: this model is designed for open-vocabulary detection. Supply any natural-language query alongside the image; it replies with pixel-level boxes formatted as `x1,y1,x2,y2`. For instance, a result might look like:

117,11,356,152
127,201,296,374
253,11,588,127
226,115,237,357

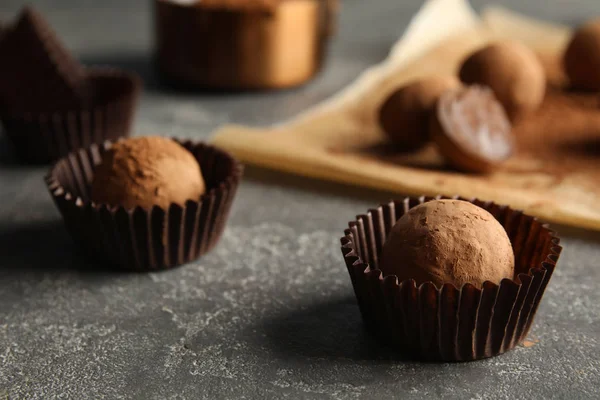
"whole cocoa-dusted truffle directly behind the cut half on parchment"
460,42,546,119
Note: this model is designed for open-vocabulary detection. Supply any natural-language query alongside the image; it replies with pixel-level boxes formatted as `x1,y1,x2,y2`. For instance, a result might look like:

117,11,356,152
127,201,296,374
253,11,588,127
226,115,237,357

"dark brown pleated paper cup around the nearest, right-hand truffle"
341,197,562,361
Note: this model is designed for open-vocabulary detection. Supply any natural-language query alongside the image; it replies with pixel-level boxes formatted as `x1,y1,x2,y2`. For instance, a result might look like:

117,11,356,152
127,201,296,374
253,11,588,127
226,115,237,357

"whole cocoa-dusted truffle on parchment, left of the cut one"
379,76,460,150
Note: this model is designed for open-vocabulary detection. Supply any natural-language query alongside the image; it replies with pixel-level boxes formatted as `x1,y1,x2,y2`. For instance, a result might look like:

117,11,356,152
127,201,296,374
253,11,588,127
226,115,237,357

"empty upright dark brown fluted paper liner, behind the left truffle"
0,68,141,163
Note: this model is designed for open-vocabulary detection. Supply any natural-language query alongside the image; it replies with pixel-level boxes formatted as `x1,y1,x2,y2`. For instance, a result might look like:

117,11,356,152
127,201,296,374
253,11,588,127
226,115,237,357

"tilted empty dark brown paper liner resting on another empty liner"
0,7,88,112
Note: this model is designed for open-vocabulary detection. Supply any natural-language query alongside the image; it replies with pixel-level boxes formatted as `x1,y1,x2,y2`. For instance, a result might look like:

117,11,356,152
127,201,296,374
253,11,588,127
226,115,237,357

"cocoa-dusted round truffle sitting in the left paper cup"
91,136,205,209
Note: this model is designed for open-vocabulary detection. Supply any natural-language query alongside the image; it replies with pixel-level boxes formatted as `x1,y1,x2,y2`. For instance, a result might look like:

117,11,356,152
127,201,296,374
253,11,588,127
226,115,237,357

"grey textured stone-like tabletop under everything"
0,0,600,399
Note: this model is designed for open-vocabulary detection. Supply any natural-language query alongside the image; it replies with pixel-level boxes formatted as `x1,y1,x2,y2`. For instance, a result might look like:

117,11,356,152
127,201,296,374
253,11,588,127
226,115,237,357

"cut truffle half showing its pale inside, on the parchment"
430,85,514,172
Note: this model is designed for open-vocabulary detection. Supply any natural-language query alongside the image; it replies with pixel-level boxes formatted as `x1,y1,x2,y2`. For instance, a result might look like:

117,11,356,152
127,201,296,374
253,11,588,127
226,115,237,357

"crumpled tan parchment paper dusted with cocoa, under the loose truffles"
212,0,600,230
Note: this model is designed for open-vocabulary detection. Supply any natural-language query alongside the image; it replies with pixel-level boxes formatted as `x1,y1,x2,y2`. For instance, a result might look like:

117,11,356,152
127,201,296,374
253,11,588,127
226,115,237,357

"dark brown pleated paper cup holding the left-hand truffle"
46,141,243,270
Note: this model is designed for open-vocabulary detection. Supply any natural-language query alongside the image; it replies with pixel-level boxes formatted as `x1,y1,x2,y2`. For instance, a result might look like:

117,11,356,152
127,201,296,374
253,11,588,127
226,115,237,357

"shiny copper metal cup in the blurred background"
155,0,337,89
